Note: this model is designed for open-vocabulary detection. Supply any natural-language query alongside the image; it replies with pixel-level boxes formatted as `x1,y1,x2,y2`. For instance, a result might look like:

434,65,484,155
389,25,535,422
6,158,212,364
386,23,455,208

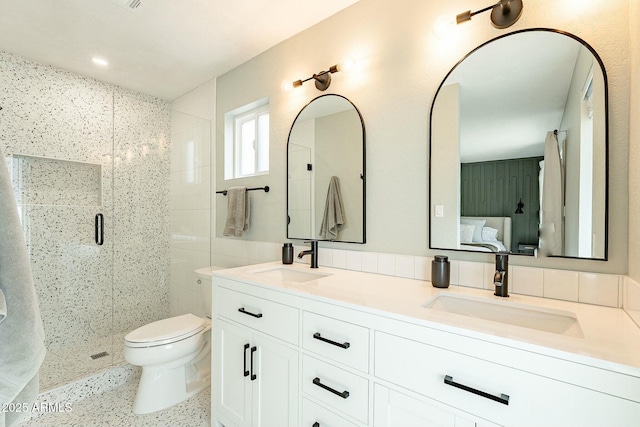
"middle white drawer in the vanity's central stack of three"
302,356,369,424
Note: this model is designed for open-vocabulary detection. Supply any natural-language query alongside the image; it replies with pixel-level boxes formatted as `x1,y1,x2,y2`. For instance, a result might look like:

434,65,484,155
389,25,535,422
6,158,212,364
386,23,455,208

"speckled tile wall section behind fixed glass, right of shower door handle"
113,94,171,332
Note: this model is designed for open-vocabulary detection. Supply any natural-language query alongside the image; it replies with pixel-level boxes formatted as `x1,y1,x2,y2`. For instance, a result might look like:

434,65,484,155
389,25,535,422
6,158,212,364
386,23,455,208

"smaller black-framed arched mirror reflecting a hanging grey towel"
287,95,365,243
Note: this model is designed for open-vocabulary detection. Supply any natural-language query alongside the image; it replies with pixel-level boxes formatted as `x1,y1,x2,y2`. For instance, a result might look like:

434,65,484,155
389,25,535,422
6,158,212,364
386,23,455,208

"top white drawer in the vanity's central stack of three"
302,311,369,372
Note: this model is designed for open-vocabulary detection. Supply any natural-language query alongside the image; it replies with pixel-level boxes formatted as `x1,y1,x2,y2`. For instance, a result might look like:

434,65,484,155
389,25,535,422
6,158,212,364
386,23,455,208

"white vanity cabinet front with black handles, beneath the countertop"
212,266,640,427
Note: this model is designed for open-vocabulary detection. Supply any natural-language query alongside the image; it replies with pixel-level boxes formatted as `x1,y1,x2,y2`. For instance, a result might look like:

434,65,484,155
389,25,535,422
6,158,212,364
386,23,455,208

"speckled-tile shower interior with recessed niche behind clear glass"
0,52,170,389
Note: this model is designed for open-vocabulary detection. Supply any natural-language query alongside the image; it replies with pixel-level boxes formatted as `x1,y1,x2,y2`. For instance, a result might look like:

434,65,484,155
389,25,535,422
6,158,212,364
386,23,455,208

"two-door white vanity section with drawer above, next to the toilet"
212,288,299,427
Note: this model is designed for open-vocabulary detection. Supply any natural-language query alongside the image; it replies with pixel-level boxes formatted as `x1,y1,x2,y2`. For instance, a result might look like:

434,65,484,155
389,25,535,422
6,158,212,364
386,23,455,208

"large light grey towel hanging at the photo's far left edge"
0,147,45,423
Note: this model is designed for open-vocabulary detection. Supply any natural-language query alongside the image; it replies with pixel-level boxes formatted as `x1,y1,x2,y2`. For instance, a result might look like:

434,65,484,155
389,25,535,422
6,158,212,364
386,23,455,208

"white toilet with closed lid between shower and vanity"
124,267,220,414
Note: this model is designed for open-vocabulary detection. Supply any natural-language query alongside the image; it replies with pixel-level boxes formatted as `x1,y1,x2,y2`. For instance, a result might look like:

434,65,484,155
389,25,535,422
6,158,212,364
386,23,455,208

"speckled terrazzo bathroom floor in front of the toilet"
20,376,211,427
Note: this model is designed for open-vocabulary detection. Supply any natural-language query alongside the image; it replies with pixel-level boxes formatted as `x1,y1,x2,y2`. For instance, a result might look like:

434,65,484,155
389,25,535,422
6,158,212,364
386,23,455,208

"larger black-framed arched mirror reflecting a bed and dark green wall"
429,29,608,260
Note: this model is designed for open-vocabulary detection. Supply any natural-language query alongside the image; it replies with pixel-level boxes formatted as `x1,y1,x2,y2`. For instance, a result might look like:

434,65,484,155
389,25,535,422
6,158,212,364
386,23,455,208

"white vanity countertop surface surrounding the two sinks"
212,262,640,377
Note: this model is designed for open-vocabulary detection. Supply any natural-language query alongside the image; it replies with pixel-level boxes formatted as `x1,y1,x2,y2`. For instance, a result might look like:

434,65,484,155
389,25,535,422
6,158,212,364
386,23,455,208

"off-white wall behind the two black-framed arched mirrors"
210,0,630,273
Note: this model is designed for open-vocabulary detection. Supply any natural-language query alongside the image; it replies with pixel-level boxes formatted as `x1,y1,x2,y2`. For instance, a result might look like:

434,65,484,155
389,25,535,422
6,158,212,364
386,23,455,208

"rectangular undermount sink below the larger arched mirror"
422,293,584,338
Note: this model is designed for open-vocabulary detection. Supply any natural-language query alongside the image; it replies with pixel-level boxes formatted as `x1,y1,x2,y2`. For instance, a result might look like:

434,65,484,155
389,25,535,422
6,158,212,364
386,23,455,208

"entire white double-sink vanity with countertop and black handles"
212,263,640,427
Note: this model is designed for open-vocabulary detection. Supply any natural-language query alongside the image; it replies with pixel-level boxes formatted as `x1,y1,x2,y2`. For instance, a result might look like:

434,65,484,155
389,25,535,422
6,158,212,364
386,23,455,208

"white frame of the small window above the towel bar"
224,98,269,180
